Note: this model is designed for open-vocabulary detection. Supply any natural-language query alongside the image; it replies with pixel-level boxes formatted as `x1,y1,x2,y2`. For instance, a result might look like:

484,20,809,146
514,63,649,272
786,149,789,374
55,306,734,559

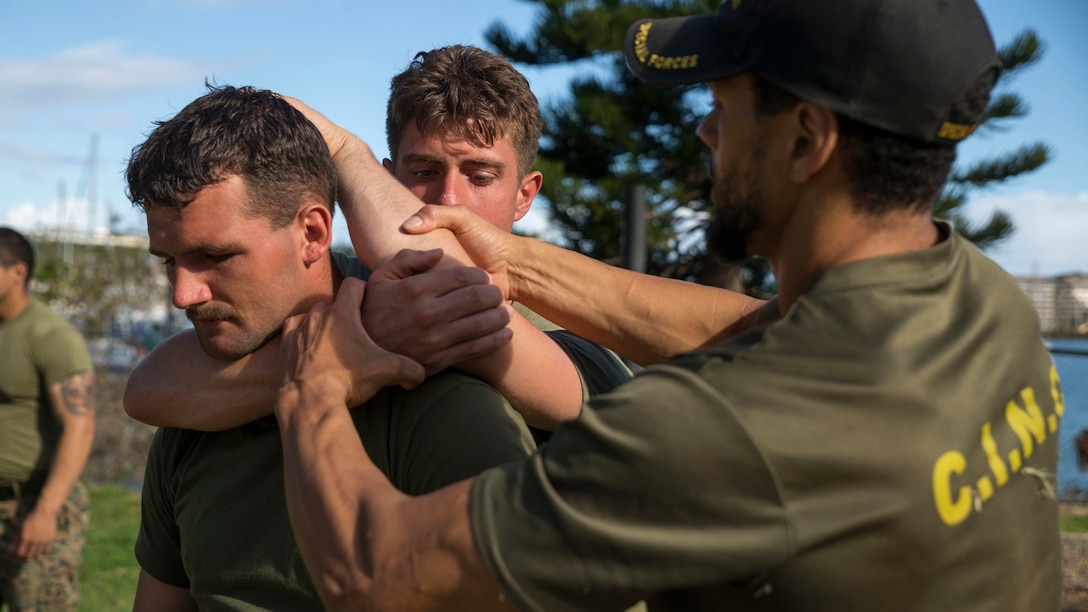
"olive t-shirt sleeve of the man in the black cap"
471,366,790,610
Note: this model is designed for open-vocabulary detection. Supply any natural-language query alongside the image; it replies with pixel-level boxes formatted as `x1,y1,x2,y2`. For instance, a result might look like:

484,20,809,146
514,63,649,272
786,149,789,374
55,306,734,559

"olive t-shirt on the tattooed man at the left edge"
0,299,94,482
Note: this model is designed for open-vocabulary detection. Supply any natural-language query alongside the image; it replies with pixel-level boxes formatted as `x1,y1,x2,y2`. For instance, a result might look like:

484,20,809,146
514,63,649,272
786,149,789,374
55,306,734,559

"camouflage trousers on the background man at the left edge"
0,484,90,612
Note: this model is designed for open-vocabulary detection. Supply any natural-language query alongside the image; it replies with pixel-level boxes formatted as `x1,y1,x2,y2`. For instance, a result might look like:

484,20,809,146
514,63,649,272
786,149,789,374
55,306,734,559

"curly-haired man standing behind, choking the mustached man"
124,45,630,433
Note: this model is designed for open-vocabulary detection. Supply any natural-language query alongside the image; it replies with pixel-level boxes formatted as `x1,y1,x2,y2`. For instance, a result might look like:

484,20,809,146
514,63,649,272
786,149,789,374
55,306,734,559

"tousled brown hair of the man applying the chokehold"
385,45,542,176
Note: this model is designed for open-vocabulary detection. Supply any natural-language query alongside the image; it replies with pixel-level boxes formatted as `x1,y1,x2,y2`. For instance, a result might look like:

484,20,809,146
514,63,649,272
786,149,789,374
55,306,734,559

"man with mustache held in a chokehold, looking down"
126,86,535,612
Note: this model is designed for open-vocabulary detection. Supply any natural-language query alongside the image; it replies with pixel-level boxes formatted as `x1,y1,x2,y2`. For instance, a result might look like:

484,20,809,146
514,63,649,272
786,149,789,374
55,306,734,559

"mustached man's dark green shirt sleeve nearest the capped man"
392,372,535,494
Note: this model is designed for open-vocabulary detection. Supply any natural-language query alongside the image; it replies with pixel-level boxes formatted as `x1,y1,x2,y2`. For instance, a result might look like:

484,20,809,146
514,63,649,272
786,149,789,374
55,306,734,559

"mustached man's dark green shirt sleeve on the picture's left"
136,428,189,588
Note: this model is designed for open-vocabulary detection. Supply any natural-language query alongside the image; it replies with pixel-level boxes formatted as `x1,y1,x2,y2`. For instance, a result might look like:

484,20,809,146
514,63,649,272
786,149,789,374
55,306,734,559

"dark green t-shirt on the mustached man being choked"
136,363,533,610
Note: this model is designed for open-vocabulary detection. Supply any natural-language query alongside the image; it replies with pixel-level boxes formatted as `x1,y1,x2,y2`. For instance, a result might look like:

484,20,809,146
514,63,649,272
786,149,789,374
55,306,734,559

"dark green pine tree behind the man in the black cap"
485,0,1050,293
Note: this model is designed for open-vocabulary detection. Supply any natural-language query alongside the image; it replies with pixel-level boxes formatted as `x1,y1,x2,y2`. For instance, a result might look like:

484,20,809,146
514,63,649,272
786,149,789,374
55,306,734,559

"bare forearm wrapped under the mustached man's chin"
124,330,282,431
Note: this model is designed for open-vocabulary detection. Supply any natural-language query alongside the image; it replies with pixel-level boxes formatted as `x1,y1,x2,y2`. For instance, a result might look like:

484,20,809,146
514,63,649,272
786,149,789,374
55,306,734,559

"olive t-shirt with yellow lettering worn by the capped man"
471,228,1063,612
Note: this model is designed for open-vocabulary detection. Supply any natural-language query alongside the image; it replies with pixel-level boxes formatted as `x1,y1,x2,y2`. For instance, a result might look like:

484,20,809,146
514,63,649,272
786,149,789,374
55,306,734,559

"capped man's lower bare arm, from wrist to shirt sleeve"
275,382,497,610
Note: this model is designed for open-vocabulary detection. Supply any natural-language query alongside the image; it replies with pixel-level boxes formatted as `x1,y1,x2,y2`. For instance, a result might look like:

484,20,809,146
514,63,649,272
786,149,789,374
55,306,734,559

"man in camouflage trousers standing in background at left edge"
0,228,95,612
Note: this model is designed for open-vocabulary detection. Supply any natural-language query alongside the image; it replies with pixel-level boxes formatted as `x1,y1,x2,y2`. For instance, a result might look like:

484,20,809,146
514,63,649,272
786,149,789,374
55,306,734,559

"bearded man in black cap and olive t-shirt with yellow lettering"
267,0,1063,611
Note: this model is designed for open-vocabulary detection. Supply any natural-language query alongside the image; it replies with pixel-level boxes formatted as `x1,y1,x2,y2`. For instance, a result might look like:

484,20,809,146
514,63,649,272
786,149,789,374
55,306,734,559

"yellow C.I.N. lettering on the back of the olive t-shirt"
932,364,1065,526
